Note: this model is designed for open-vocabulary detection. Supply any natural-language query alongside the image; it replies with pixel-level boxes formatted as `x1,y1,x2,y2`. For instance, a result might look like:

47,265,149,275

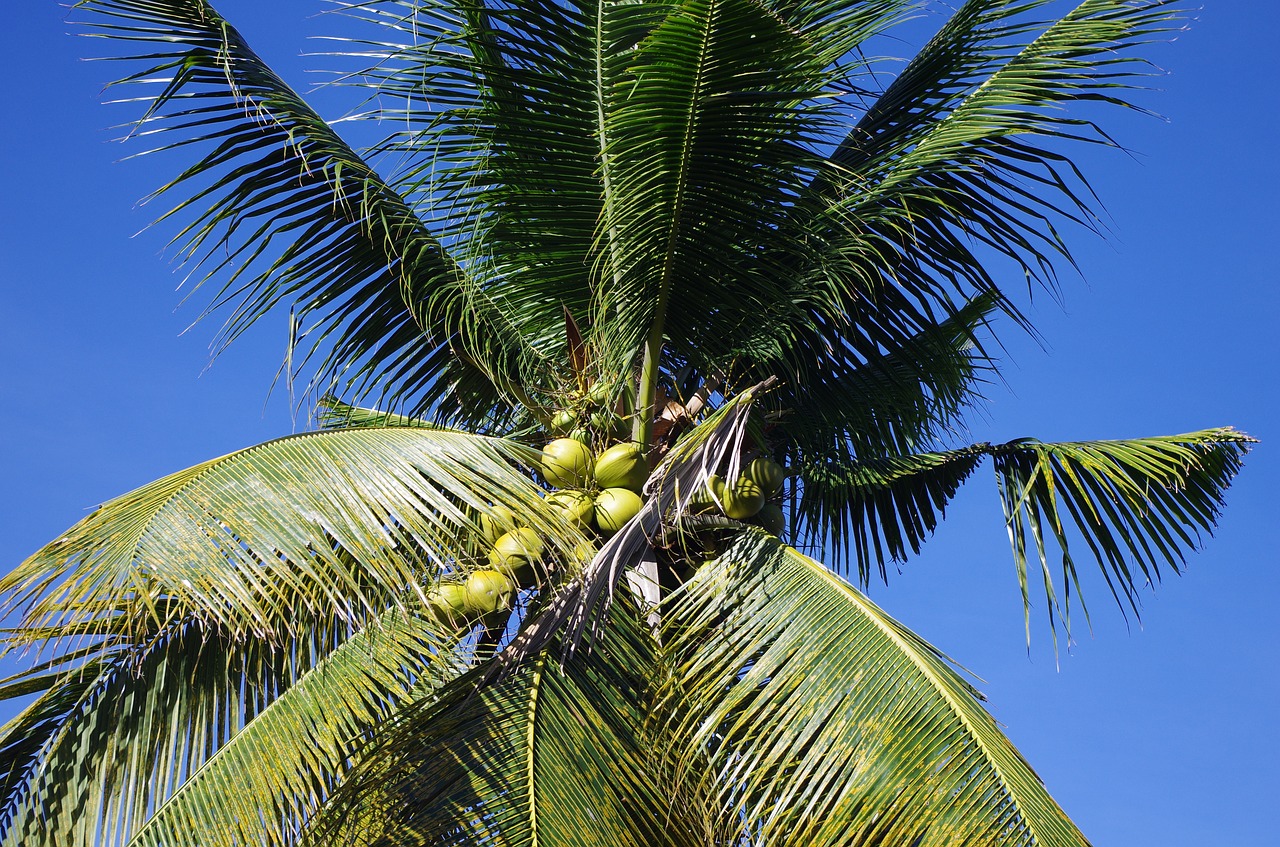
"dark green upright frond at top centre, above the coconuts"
600,0,828,357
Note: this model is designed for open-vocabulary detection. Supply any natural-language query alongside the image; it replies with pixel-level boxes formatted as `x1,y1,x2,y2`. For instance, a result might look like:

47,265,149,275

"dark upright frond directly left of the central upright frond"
330,0,609,373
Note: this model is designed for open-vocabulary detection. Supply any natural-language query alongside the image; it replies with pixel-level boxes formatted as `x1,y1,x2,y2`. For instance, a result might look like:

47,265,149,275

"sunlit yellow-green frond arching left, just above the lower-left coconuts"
0,427,570,644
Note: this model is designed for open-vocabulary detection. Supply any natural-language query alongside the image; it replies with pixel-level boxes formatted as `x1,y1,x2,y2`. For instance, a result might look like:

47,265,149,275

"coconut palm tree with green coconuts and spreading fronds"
0,0,1249,846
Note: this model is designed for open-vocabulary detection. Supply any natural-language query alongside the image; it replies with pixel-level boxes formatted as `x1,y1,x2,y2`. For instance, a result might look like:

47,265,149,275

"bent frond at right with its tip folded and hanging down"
800,429,1253,640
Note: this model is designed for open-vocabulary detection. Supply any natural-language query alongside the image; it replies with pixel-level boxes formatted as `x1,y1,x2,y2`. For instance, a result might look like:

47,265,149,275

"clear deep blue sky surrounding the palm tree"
0,0,1280,847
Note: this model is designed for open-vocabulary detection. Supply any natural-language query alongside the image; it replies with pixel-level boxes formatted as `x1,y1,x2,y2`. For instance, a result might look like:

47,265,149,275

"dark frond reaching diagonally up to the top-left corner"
78,0,538,421
